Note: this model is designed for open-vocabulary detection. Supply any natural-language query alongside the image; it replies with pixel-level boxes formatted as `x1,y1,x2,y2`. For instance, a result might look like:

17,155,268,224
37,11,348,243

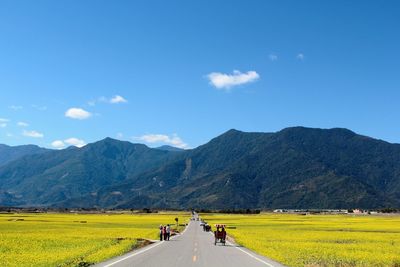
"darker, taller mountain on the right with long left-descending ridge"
58,127,400,209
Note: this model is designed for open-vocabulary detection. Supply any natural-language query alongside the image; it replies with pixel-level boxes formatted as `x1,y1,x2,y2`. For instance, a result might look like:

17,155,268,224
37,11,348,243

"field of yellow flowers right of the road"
202,214,400,267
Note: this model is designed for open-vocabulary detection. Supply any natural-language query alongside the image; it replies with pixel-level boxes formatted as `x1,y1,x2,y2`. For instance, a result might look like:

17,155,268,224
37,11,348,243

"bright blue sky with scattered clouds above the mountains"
0,0,400,148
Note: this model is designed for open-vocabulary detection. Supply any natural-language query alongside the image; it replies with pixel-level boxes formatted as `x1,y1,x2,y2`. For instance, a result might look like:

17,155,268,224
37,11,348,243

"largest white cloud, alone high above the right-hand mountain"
207,70,260,91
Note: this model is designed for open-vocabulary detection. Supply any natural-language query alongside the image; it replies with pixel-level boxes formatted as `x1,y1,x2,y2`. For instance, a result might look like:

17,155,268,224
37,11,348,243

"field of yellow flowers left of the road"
0,213,189,267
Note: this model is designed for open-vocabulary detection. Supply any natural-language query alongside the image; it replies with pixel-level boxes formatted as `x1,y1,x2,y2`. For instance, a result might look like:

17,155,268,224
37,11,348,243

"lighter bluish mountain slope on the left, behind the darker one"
0,138,180,206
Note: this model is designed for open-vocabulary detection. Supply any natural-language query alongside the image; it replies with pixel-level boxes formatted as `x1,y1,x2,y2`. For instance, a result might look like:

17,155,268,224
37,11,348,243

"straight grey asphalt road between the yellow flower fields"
96,216,283,267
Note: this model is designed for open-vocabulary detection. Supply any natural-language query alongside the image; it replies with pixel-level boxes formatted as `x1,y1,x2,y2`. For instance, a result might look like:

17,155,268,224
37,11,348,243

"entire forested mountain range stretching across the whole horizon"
0,127,400,209
